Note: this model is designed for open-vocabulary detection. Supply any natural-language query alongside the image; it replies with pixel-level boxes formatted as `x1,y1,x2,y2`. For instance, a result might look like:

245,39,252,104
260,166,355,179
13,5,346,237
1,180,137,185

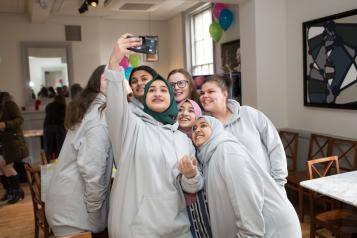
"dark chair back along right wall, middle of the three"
307,134,331,160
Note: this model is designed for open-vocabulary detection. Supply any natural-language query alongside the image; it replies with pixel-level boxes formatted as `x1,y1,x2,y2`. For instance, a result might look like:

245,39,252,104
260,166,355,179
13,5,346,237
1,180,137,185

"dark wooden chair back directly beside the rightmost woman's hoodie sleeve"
279,130,299,171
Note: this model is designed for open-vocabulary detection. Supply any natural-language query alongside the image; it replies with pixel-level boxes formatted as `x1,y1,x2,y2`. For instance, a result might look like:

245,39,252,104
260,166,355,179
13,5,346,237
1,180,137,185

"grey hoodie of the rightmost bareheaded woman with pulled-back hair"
224,99,288,187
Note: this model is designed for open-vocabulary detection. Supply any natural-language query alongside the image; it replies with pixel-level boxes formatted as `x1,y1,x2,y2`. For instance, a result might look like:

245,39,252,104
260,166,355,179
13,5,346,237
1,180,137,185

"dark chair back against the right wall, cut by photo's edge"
329,138,357,171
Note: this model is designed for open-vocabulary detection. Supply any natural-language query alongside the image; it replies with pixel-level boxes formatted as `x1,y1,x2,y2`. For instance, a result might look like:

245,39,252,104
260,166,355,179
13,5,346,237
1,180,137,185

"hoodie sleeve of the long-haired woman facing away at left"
77,124,111,223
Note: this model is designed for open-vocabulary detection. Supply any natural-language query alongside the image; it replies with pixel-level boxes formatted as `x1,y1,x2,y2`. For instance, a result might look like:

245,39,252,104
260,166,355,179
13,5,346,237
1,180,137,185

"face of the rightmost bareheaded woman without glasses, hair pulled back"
200,82,228,114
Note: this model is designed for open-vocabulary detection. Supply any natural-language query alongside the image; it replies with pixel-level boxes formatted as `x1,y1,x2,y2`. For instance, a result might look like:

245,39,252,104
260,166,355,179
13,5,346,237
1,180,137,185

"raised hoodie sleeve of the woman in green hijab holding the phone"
104,66,138,166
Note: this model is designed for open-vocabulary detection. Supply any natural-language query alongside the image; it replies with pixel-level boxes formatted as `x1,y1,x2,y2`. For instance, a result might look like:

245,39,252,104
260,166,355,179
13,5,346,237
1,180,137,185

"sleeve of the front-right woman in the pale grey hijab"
216,147,265,238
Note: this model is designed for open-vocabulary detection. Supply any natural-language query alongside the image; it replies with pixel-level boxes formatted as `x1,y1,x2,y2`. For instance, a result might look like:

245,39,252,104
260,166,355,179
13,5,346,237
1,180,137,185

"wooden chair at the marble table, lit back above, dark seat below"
306,156,357,238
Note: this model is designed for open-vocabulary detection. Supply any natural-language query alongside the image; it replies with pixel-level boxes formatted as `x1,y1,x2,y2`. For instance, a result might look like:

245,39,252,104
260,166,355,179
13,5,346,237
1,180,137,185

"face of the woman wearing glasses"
169,73,190,102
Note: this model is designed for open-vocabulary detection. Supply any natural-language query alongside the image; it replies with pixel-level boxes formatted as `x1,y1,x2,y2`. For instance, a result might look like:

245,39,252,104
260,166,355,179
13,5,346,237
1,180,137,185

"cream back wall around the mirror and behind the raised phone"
0,14,169,106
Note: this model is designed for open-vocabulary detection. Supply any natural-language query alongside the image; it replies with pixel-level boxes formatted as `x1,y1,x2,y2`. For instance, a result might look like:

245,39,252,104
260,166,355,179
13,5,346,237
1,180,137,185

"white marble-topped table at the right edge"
300,171,357,207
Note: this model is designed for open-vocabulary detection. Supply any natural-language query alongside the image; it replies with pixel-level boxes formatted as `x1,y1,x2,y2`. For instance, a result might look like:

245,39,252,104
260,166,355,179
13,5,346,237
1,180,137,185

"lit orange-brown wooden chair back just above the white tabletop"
306,156,340,179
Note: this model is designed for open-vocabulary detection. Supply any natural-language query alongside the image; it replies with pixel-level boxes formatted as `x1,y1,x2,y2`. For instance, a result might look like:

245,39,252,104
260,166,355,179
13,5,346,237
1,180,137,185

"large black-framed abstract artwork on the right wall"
302,9,357,110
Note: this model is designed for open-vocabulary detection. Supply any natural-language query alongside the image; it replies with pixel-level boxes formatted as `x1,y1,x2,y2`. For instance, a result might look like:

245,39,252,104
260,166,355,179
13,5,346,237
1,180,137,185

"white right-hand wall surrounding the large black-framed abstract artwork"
286,0,357,138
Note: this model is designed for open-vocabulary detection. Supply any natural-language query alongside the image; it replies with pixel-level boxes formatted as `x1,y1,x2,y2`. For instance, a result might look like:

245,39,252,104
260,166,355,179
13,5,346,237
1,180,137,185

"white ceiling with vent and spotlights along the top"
0,0,239,23
